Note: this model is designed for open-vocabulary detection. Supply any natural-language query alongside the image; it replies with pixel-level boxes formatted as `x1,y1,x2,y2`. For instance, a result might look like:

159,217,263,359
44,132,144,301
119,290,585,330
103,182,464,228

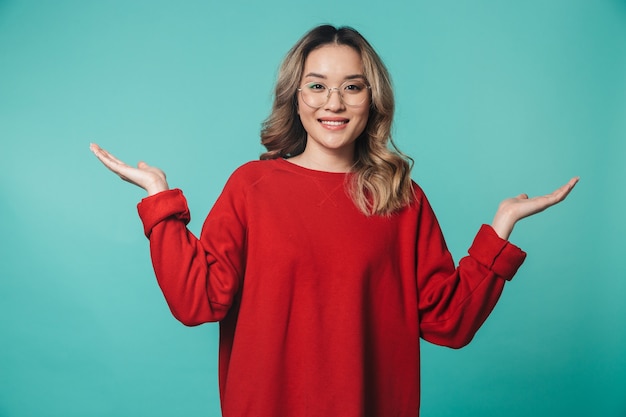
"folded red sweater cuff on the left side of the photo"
137,188,191,239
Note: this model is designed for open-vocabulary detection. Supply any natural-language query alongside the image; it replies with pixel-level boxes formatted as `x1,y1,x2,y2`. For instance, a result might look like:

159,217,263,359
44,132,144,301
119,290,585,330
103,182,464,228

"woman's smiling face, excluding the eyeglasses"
298,44,371,162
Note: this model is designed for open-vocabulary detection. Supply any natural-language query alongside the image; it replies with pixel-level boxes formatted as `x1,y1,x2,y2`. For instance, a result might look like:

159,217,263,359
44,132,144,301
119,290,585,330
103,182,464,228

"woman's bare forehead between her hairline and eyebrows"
303,44,363,78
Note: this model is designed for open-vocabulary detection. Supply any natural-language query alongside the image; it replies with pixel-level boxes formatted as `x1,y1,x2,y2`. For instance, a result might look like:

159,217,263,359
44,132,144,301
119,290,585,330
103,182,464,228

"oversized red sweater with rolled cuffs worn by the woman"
138,159,525,417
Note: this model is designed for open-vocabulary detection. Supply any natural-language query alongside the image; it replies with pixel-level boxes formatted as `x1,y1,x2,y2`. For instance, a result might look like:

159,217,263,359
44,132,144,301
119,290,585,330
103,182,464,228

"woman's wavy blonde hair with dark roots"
261,25,413,215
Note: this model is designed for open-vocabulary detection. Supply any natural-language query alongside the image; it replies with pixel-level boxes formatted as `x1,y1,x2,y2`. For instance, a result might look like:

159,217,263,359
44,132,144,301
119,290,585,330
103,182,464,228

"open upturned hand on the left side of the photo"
89,143,169,195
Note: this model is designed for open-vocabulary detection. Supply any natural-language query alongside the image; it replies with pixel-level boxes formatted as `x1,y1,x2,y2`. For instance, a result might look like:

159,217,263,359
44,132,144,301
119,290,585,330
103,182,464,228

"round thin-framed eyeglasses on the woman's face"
298,80,371,109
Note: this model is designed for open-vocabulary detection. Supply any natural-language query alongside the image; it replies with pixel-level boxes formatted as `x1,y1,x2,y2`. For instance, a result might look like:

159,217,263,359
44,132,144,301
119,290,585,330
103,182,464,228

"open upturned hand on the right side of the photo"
491,177,579,240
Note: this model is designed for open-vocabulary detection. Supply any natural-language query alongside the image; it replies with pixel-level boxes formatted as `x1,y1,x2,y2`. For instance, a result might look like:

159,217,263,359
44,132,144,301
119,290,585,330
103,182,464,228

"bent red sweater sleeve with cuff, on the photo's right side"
417,190,526,348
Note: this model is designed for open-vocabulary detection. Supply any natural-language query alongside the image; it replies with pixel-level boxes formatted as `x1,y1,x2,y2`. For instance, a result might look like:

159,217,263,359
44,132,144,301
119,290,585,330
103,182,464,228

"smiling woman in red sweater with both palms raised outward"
91,26,577,417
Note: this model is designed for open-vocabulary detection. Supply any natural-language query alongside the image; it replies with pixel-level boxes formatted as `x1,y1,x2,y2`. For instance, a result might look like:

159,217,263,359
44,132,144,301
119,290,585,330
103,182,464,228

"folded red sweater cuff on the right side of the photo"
469,224,526,281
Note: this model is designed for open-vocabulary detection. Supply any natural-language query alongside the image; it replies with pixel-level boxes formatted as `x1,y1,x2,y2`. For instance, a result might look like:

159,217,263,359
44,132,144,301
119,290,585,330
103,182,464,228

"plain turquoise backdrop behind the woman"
0,0,626,417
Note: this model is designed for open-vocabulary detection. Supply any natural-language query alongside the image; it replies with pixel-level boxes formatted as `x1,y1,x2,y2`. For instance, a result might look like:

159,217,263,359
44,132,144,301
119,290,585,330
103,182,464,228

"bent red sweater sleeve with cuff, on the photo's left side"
137,176,245,326
